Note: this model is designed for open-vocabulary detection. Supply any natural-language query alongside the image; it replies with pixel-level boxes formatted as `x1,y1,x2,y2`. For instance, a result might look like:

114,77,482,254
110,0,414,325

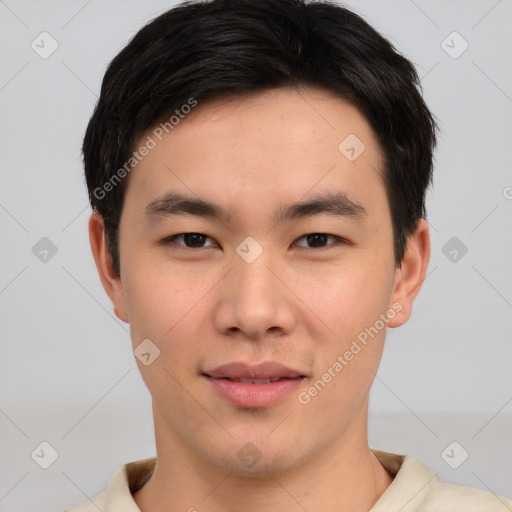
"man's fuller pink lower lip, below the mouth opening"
206,376,304,408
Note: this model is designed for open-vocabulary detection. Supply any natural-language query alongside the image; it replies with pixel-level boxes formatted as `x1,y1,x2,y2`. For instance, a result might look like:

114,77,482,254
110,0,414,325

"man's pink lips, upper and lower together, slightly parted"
202,362,306,408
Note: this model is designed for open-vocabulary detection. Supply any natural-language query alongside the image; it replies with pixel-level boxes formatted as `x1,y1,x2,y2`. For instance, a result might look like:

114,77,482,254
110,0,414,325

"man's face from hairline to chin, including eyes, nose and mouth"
91,89,424,475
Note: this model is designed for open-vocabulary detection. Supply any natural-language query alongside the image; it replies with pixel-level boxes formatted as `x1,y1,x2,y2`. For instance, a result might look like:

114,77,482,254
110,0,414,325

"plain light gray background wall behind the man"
0,0,512,512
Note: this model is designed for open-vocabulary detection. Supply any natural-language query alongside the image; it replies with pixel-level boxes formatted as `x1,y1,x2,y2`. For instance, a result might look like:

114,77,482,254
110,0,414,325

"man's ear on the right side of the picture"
388,219,430,327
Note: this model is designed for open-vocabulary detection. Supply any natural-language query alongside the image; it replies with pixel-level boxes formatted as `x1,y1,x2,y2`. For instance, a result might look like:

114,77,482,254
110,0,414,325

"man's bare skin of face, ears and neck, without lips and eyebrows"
89,88,430,512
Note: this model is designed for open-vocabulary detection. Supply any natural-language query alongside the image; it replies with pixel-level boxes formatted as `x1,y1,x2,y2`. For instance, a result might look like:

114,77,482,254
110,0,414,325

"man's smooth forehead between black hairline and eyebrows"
127,88,385,222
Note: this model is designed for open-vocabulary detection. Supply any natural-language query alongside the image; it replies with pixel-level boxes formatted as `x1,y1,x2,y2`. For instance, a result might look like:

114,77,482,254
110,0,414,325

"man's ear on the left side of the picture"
89,212,128,323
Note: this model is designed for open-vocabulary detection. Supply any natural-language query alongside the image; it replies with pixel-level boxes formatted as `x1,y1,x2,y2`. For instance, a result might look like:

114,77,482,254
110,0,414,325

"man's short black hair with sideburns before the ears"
82,0,437,275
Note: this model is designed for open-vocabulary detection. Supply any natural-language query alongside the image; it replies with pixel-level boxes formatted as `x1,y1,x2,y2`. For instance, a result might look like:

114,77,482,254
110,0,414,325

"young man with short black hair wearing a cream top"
65,0,512,512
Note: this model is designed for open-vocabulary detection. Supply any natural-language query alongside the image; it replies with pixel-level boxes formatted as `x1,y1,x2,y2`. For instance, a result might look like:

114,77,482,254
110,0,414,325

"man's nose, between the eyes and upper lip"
213,247,296,340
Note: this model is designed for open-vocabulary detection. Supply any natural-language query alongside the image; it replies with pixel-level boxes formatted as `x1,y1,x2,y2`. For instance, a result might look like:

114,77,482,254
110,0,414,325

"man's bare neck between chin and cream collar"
134,406,393,512
